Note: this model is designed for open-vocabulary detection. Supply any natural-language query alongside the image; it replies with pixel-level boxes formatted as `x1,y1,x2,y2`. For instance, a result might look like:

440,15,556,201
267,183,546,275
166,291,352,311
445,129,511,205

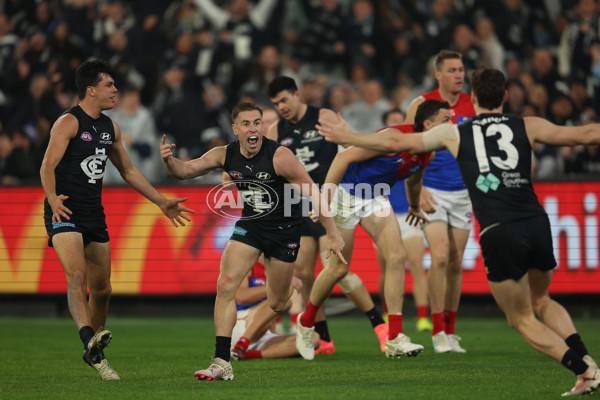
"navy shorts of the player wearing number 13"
479,215,556,282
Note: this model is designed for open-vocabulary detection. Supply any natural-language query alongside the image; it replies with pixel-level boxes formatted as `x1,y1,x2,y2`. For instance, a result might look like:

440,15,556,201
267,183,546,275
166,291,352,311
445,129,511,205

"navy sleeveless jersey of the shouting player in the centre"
225,137,301,227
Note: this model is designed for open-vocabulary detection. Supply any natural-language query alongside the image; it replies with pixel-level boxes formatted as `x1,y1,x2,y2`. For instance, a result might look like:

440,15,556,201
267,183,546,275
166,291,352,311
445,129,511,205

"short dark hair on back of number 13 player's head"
471,67,506,110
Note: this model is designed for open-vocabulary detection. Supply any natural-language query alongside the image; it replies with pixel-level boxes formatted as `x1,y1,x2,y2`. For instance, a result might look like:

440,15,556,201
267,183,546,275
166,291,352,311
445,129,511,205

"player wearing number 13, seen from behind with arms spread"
316,68,600,396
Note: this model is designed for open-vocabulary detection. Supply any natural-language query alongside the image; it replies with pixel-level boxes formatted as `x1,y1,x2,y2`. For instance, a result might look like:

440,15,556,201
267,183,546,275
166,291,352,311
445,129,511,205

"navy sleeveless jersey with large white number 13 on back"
456,114,546,231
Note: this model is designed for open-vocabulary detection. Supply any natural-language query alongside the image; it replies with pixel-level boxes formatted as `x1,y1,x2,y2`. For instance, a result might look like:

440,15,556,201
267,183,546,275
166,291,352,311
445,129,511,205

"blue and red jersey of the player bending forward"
340,125,431,198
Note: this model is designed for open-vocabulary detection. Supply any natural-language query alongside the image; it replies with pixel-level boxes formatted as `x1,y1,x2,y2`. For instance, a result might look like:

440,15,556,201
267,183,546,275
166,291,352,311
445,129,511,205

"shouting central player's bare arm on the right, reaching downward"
273,147,347,264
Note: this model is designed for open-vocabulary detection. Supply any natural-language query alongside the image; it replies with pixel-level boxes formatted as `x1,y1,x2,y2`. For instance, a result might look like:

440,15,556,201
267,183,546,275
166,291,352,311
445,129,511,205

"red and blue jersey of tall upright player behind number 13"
423,89,475,192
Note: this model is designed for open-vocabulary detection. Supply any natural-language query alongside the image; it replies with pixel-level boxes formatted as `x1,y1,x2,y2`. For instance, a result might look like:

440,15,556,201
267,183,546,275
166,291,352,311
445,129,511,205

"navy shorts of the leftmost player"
44,202,110,247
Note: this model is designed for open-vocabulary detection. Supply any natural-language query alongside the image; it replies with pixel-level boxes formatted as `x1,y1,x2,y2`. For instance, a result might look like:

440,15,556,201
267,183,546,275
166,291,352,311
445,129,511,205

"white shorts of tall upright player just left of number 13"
425,188,473,231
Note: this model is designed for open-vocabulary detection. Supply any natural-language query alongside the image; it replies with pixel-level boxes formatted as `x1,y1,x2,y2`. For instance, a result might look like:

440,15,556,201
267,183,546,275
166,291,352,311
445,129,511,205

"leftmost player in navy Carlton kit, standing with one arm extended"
40,60,193,380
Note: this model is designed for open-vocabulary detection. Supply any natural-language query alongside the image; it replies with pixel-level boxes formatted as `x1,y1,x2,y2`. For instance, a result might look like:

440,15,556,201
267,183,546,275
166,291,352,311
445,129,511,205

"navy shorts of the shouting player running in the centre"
230,220,300,263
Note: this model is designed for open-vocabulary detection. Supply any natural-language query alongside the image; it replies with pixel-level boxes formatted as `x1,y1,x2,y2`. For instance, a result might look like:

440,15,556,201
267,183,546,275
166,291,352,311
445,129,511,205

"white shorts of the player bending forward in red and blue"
331,186,393,229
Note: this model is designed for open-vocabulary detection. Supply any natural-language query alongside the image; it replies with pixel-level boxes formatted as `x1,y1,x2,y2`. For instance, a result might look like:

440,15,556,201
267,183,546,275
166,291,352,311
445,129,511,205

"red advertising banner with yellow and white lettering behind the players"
0,182,600,294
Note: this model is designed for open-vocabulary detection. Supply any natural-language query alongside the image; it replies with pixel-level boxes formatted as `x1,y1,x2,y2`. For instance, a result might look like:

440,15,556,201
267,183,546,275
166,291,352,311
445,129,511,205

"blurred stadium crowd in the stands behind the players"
0,0,600,185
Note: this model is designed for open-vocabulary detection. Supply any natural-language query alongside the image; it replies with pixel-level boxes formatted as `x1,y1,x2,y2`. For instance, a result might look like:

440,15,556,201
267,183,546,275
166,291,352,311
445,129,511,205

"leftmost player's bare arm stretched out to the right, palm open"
109,122,194,227
